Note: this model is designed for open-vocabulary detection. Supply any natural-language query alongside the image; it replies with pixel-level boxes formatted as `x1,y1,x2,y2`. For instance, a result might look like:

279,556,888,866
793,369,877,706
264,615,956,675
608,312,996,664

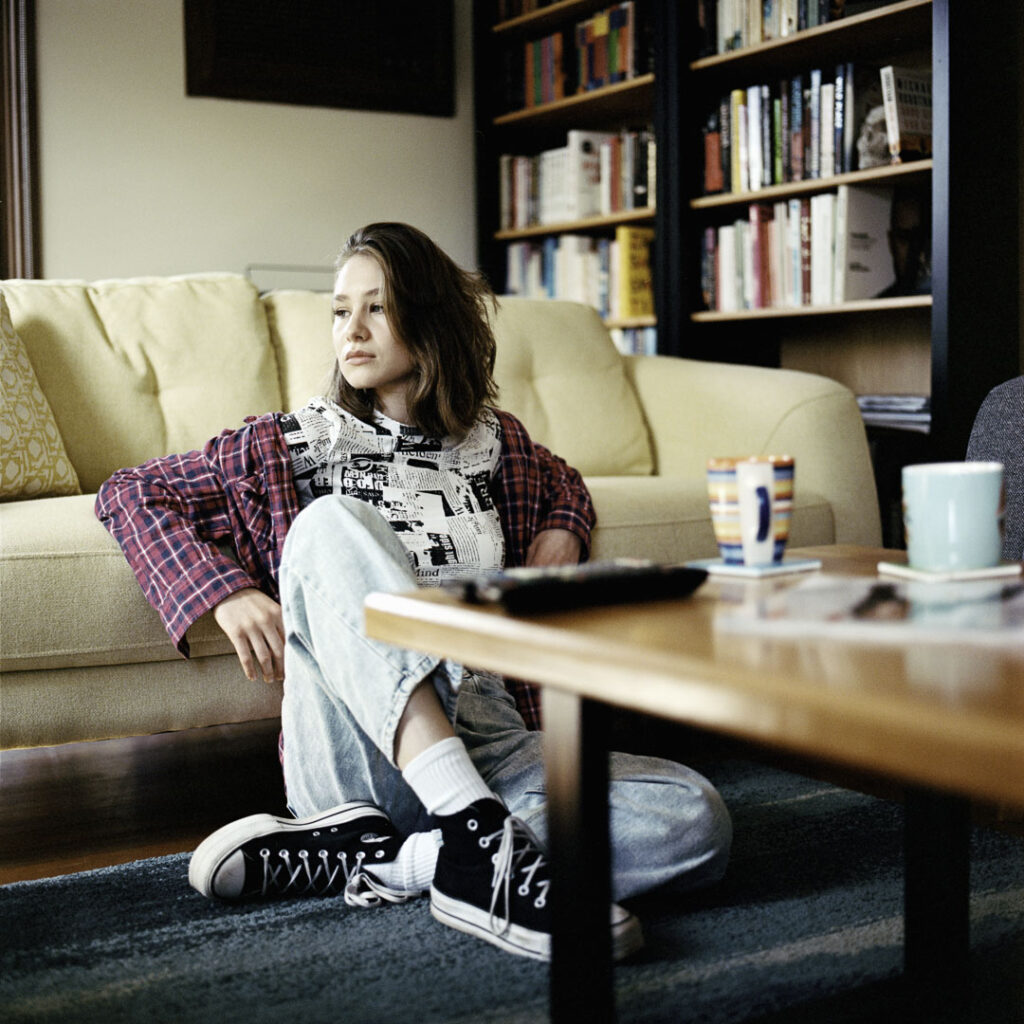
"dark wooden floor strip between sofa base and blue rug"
0,722,285,885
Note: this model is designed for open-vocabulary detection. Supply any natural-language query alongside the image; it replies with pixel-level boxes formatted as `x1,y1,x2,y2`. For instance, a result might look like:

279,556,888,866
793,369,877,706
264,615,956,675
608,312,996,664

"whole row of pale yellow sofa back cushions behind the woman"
0,273,653,493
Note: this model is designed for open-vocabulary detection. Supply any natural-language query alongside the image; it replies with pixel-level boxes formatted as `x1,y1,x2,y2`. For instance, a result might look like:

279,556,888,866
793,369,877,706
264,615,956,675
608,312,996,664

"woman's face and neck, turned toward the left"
333,255,416,423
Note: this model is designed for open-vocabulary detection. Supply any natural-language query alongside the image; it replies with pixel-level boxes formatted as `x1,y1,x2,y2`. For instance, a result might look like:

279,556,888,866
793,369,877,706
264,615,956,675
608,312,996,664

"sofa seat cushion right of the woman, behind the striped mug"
587,476,836,562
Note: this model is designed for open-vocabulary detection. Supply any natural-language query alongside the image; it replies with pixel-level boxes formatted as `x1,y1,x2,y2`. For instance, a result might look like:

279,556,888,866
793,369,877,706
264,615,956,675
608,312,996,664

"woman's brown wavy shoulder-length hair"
330,223,498,437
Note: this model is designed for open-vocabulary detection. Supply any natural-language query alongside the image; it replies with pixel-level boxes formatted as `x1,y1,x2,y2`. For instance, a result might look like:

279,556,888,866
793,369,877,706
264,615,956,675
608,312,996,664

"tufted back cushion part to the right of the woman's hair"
495,298,654,476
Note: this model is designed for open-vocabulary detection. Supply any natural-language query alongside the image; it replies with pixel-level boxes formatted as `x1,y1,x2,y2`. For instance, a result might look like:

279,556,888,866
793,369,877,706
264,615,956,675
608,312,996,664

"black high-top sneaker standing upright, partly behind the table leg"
430,800,643,961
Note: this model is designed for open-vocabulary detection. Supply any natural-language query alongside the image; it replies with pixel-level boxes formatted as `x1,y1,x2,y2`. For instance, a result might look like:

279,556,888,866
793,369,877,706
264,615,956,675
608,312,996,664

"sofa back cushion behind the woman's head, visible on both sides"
263,291,653,476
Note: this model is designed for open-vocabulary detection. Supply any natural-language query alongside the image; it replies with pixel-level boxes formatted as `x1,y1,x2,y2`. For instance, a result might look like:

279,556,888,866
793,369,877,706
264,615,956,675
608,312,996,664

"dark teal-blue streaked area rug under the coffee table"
0,761,1024,1024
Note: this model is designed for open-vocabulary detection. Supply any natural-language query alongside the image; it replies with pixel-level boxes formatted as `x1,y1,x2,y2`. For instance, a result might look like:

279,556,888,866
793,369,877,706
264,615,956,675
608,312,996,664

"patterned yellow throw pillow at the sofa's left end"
0,291,81,499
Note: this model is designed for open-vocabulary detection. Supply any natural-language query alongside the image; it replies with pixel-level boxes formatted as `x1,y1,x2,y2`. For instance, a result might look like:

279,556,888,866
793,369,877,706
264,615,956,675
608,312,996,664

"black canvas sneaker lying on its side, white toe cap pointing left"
188,801,416,906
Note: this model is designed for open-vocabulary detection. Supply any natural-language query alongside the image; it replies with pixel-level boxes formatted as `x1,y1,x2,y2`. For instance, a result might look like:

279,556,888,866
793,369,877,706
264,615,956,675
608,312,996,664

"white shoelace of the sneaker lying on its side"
260,837,409,907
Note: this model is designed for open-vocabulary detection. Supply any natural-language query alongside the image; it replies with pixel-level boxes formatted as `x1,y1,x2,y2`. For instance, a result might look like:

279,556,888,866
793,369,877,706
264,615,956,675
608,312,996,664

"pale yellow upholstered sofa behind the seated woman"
0,274,880,748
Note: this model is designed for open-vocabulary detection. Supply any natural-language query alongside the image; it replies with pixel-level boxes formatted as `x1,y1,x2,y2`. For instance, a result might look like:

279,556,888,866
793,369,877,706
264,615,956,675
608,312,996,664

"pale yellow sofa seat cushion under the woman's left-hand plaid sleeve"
0,495,232,671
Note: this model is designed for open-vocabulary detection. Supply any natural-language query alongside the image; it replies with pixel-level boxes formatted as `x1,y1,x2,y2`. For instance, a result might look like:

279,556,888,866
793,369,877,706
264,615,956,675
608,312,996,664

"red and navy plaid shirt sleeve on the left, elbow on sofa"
96,417,297,656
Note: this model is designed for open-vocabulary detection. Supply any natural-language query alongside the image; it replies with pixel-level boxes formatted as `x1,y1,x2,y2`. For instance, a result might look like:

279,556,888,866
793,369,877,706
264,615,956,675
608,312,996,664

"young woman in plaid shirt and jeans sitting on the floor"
96,223,731,958
